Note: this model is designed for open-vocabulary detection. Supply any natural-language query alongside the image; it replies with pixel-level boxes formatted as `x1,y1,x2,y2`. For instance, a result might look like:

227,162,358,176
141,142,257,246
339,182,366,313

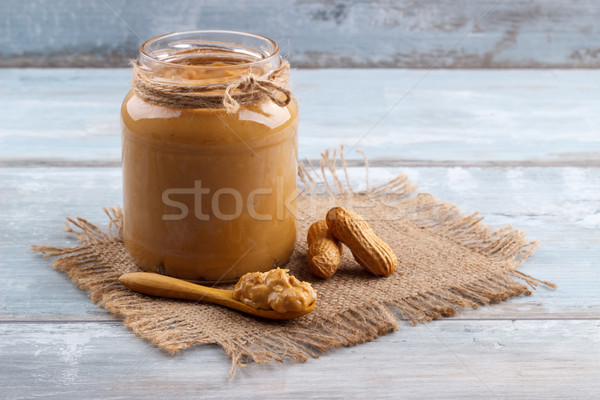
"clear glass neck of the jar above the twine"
137,31,282,86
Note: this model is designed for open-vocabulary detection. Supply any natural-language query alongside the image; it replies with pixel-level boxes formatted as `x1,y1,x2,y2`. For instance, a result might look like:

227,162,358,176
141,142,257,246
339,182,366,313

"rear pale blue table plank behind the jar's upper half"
0,69,600,165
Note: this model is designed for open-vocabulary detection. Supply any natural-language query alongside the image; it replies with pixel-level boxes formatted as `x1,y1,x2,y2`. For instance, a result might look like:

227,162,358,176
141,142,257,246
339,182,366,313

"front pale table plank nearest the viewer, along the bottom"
0,320,600,399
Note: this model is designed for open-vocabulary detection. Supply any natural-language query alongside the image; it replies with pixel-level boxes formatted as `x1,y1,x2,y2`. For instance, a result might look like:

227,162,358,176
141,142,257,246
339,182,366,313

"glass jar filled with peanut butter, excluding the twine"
121,31,298,282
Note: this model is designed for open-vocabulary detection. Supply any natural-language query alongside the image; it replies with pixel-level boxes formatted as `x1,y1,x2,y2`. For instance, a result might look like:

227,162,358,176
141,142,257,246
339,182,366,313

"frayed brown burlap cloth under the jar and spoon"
32,150,554,373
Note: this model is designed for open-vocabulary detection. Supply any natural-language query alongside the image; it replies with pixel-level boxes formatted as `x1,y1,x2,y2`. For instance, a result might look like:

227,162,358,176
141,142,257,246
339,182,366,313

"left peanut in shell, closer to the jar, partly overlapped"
306,220,342,278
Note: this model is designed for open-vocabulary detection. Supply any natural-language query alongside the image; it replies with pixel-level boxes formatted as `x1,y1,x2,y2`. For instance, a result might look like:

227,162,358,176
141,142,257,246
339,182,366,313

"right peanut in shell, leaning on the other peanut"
327,207,398,276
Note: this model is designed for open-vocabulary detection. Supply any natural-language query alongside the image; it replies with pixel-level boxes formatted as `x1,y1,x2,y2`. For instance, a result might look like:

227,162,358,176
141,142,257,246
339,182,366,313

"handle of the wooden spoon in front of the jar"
119,272,232,304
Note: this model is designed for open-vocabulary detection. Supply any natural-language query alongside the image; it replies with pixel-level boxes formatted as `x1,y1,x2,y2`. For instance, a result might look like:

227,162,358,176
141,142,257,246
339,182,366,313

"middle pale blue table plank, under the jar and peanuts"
0,168,600,321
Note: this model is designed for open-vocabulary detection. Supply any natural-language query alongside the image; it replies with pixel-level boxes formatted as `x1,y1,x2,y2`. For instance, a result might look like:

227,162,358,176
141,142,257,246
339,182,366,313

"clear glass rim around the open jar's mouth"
140,29,280,70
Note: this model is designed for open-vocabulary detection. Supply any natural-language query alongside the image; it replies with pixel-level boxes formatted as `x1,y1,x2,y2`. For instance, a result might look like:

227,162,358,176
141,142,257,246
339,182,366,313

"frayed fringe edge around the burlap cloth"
31,148,556,376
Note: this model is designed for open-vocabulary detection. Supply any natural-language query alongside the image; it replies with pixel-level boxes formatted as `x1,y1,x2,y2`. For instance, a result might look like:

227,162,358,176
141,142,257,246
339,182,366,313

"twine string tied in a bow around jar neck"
132,57,292,113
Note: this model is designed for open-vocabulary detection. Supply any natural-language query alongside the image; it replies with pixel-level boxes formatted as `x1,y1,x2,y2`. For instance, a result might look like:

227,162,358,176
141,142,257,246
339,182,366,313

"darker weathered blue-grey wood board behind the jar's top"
0,0,600,68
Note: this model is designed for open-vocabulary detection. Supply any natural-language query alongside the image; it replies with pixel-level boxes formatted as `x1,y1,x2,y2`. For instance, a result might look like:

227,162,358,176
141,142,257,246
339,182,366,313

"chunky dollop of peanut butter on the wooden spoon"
233,268,317,313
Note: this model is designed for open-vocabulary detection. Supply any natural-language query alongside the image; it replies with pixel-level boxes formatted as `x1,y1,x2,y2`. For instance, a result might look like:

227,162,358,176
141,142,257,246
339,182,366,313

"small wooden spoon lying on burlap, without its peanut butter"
119,272,315,319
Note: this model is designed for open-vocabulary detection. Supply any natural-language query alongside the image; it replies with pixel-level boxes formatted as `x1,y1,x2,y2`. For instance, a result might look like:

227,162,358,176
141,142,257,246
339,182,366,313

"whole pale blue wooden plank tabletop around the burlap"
0,69,600,399
